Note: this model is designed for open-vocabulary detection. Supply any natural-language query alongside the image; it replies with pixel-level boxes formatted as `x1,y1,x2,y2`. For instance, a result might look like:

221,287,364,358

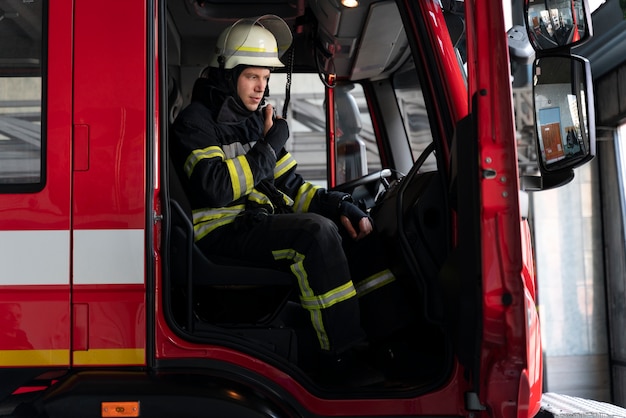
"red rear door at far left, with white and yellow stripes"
0,0,72,367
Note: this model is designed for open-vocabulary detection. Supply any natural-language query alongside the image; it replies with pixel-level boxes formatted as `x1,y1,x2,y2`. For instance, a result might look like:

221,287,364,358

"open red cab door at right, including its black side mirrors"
464,0,595,417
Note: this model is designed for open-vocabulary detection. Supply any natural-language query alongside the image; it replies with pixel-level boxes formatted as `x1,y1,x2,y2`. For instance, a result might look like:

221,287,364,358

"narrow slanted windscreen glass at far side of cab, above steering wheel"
392,69,437,171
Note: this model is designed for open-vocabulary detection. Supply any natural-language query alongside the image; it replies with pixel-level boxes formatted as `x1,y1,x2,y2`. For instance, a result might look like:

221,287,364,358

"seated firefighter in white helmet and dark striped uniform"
171,15,410,385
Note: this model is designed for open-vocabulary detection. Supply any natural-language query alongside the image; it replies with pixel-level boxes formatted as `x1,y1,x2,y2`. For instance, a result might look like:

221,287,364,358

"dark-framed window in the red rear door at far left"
0,0,45,192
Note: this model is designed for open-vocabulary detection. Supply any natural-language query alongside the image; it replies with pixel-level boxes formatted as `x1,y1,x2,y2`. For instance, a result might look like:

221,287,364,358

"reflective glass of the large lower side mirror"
534,56,595,171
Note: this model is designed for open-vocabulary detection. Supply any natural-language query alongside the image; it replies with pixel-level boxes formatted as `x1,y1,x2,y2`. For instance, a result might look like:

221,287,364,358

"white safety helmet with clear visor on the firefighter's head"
209,15,293,70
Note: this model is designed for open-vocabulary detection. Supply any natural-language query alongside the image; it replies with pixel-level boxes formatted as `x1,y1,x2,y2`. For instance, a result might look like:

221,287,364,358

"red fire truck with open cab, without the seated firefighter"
0,0,594,418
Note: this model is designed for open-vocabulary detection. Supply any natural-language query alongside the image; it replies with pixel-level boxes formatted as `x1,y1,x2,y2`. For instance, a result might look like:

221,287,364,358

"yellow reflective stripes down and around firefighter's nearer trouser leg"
272,249,356,350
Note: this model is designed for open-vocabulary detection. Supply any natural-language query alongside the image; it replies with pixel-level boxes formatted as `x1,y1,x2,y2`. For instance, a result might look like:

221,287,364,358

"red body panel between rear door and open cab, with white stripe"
72,0,147,365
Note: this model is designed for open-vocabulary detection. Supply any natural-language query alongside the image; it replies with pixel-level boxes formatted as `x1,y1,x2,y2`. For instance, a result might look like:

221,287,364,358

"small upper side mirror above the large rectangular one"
524,0,593,51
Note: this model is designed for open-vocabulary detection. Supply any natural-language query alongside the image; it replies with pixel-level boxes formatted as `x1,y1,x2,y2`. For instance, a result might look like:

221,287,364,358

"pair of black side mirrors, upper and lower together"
520,0,596,191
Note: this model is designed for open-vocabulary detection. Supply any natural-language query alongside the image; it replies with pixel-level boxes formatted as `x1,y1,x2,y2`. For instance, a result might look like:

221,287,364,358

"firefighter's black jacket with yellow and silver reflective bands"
170,79,351,241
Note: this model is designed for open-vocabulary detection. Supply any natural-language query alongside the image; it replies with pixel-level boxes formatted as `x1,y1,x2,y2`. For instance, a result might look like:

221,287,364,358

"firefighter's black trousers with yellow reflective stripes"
198,212,411,354
